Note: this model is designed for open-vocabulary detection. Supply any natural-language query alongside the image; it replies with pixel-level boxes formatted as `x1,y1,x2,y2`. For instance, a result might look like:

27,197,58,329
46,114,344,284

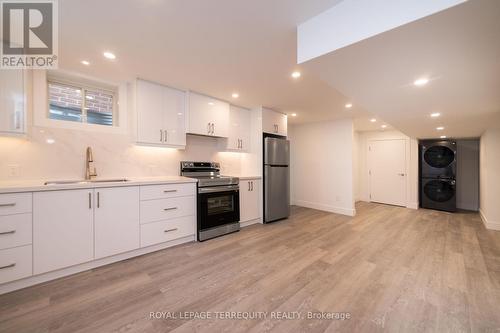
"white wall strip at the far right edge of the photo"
479,129,500,230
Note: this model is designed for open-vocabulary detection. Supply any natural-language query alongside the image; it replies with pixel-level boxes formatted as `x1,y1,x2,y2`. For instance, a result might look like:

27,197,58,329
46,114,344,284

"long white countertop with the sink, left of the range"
0,176,197,194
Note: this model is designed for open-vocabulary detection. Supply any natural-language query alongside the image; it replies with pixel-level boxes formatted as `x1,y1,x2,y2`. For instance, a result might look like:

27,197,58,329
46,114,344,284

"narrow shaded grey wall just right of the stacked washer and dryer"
456,139,479,211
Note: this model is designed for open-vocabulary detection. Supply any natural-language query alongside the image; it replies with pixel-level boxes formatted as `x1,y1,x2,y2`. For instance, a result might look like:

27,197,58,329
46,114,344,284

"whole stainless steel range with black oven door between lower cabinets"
181,161,240,241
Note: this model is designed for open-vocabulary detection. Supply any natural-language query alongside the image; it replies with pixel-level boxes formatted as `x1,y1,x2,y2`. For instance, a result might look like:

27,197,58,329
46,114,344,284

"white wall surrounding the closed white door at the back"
356,131,419,209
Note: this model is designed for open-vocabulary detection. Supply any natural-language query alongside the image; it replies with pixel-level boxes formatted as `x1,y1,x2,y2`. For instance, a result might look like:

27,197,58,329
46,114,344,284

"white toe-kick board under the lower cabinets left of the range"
0,235,196,295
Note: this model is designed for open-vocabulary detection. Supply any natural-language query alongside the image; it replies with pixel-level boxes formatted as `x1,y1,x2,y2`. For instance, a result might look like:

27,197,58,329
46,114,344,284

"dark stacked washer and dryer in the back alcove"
420,140,457,212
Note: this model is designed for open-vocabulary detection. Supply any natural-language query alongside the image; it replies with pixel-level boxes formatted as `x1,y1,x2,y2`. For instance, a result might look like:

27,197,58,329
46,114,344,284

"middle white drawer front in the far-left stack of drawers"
0,213,33,250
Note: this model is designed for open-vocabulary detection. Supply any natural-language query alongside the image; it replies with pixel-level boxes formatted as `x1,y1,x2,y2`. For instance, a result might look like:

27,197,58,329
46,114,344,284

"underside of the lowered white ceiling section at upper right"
304,0,500,138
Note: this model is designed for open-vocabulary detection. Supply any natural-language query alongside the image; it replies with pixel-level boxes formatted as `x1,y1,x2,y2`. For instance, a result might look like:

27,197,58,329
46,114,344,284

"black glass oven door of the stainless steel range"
198,185,240,230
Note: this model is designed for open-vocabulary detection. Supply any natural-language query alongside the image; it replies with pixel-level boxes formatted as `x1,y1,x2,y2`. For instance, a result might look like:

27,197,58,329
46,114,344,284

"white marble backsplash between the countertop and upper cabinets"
0,127,244,181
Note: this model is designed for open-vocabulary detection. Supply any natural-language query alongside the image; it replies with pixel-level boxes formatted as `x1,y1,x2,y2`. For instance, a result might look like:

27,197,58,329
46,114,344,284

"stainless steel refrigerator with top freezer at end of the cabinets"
264,137,290,223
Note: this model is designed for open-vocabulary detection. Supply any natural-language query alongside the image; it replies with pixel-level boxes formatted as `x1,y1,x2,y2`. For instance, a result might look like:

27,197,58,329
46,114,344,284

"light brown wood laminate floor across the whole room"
0,203,500,333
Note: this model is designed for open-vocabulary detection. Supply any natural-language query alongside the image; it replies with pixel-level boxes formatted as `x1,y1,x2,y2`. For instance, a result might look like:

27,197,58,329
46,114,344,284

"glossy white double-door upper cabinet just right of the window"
135,80,186,148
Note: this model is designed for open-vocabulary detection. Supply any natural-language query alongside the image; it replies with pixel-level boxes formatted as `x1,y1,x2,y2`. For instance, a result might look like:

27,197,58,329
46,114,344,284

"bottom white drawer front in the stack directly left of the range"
141,216,196,247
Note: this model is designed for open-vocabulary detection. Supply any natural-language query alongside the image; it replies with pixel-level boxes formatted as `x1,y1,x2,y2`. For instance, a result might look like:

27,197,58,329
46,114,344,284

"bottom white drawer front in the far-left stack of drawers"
0,245,33,284
